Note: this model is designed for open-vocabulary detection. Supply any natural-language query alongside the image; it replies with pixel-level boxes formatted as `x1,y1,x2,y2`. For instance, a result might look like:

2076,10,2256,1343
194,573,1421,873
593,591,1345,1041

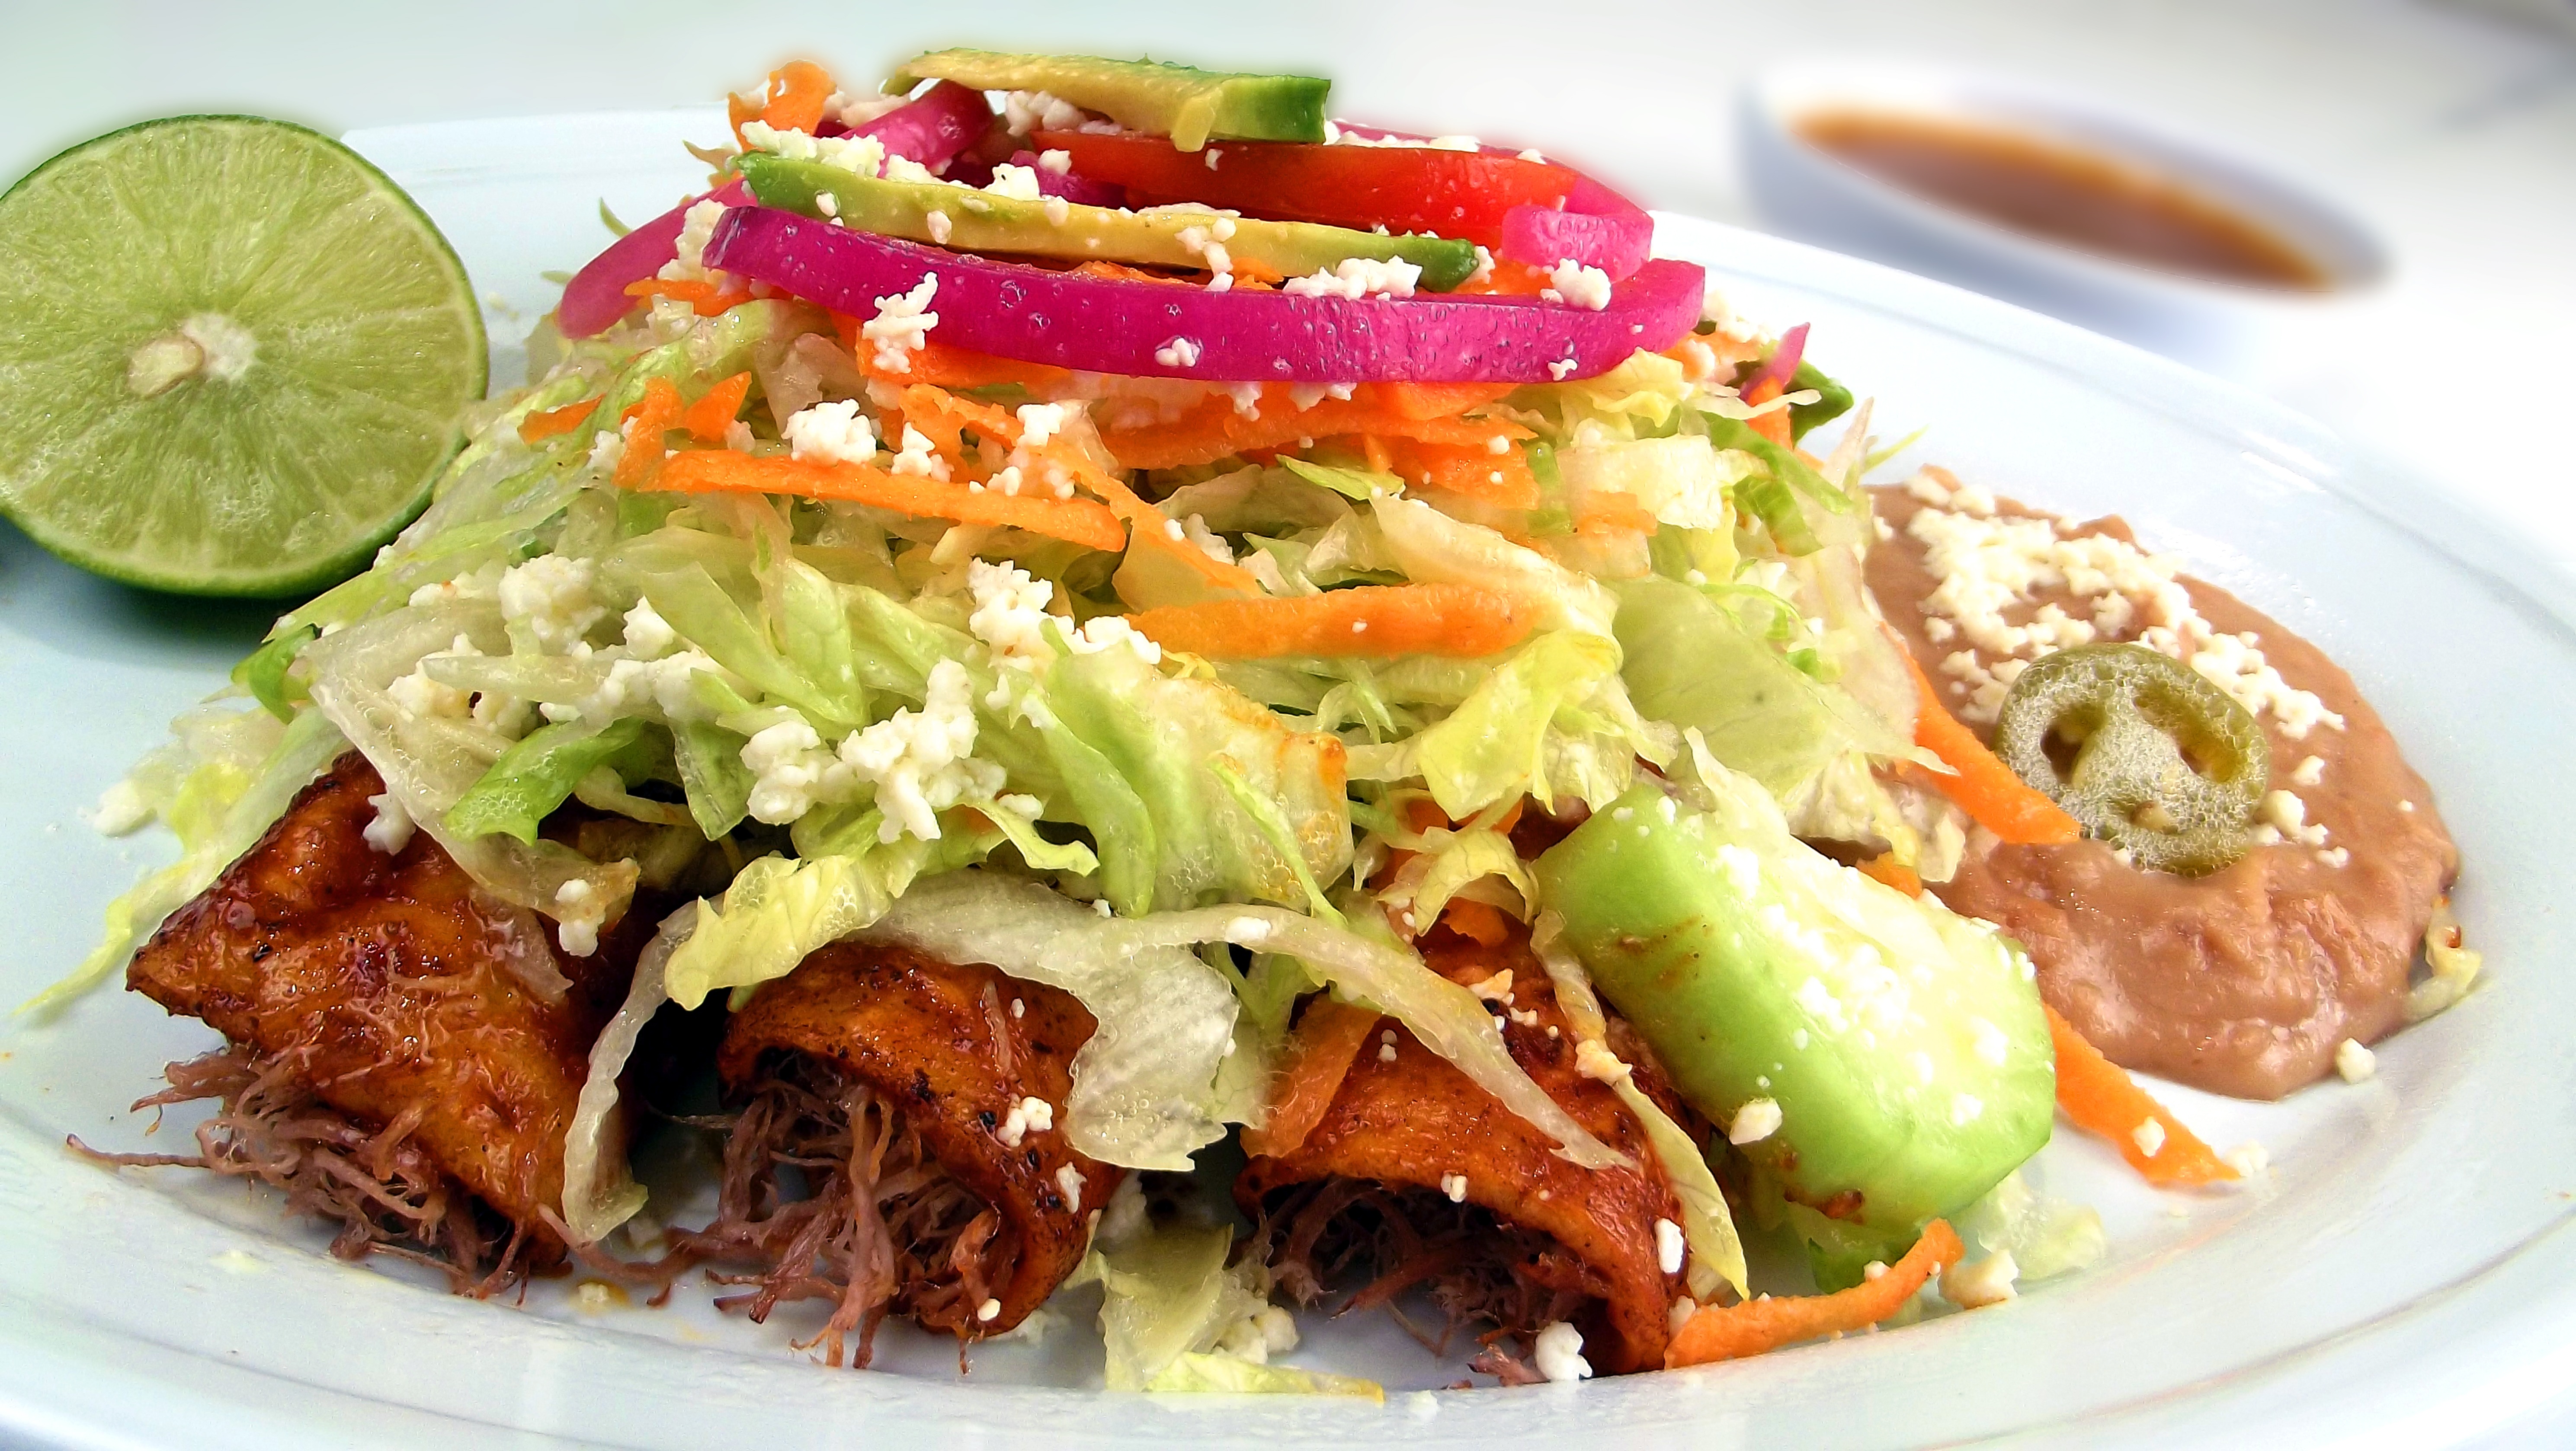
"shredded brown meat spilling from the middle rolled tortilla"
673,1054,1020,1366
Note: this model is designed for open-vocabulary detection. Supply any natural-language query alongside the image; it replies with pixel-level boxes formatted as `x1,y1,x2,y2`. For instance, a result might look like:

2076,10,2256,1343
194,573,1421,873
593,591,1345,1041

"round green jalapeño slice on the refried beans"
1994,644,2272,876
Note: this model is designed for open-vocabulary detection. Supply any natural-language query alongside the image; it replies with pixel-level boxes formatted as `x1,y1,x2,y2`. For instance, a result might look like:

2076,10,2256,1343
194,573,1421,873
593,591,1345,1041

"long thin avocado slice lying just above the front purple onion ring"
737,152,1476,291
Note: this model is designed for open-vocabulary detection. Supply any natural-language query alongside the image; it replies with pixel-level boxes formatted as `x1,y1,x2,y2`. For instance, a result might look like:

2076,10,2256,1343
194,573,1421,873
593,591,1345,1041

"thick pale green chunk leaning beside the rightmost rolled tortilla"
1538,760,2056,1284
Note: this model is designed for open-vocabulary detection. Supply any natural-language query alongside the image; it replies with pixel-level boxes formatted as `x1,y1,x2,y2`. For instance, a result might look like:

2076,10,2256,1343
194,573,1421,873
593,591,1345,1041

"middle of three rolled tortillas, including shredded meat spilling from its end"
675,943,1121,1366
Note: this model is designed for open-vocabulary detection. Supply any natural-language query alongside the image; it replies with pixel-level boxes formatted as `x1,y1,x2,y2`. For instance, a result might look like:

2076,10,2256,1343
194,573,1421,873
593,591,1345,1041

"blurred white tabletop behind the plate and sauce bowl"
0,0,2576,1446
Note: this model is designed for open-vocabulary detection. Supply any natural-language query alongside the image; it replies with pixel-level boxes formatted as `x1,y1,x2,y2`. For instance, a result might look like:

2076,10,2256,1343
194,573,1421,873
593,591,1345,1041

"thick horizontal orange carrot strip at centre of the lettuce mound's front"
1128,585,1533,660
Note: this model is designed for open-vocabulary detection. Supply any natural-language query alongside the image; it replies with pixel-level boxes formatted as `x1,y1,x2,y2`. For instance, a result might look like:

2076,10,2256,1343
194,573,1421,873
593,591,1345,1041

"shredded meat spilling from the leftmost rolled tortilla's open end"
70,1046,528,1299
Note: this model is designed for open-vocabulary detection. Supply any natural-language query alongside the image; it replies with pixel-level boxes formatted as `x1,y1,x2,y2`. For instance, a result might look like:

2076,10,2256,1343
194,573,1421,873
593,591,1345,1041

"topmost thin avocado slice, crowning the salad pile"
886,49,1332,152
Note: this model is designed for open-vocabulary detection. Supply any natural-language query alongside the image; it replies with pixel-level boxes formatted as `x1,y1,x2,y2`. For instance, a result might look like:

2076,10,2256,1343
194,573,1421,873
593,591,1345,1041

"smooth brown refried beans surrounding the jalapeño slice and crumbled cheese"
1868,469,2460,1098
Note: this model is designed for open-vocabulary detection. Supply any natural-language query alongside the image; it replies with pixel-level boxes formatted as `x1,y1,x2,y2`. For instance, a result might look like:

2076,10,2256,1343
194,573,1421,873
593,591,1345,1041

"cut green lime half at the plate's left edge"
0,116,484,595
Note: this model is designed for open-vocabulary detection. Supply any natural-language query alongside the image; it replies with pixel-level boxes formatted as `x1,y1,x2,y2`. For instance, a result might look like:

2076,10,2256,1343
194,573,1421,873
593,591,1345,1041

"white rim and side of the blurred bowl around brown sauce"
1739,59,2388,374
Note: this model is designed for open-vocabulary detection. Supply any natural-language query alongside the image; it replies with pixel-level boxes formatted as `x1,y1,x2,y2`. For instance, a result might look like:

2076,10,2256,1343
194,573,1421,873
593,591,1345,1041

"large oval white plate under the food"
0,111,2576,1451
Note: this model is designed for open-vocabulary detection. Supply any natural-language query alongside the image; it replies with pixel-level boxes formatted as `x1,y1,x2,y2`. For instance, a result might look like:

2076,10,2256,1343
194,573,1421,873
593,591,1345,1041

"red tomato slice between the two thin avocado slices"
1030,131,1582,247
